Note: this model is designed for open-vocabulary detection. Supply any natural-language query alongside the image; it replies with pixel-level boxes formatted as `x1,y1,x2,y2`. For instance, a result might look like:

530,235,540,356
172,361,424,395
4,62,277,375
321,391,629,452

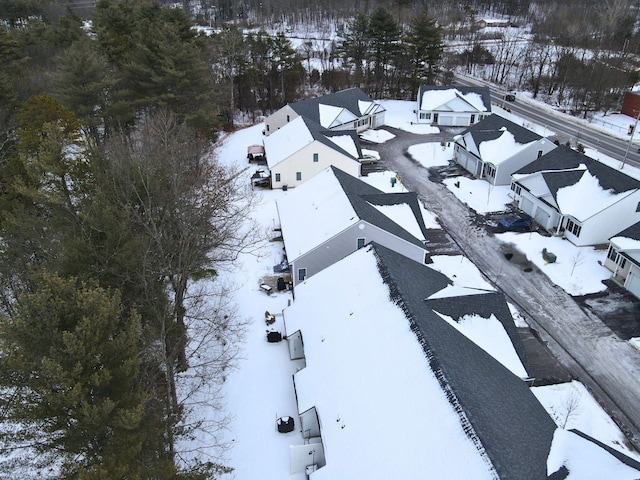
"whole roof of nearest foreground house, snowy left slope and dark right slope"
285,244,555,479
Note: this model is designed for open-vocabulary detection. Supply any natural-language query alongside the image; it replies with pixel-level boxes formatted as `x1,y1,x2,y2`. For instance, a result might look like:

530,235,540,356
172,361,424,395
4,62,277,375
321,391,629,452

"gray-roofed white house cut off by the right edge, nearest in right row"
604,222,640,299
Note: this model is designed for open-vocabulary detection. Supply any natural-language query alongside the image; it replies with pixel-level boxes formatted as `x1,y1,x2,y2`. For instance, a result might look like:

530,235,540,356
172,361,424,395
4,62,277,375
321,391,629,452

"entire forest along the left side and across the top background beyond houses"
0,0,640,479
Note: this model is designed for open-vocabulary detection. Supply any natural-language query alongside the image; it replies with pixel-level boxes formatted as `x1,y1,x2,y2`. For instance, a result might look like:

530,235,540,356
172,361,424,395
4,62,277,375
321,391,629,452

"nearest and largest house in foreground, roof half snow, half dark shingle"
283,242,636,480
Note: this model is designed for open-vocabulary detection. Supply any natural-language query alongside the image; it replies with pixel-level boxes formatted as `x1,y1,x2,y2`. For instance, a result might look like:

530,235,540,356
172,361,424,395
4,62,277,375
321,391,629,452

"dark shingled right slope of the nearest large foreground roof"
374,244,556,480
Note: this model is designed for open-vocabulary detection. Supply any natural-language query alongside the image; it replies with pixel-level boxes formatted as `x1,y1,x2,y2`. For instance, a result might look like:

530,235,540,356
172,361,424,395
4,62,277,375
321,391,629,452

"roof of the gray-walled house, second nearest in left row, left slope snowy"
278,167,426,261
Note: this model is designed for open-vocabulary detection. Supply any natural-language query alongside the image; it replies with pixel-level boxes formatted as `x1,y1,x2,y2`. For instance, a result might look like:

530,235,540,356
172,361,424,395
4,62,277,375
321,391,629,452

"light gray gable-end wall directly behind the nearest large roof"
292,220,427,287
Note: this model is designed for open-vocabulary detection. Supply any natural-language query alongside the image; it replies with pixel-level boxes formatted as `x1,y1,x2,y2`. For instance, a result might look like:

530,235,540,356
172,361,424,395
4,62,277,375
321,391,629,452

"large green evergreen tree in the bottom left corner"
0,276,145,478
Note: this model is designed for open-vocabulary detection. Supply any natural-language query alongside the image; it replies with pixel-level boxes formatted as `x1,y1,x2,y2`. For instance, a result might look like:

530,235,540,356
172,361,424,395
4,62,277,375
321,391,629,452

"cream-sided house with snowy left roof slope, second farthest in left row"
264,117,362,188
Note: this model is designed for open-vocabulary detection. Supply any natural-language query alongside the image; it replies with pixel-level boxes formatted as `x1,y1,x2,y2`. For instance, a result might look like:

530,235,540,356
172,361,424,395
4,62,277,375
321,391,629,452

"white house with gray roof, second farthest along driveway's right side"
454,115,556,185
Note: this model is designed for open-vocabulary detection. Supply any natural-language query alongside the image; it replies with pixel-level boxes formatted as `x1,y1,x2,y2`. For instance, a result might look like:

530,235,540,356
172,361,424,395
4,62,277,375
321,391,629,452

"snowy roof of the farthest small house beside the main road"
418,85,491,112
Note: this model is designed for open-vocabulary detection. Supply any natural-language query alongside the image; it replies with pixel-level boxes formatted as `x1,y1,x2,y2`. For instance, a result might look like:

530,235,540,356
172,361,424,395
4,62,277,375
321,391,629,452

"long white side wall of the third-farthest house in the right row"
565,191,640,246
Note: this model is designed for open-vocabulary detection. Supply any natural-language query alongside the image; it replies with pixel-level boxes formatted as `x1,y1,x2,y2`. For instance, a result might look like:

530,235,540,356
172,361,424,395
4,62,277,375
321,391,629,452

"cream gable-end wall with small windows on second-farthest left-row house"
271,141,360,188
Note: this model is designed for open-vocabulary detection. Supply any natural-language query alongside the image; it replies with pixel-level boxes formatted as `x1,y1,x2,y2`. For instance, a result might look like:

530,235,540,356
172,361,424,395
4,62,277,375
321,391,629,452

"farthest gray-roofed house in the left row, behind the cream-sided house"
263,88,385,136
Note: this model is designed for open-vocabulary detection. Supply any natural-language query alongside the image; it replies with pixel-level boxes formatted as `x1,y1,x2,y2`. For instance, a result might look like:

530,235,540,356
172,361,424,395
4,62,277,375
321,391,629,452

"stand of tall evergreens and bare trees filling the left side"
0,0,258,479
